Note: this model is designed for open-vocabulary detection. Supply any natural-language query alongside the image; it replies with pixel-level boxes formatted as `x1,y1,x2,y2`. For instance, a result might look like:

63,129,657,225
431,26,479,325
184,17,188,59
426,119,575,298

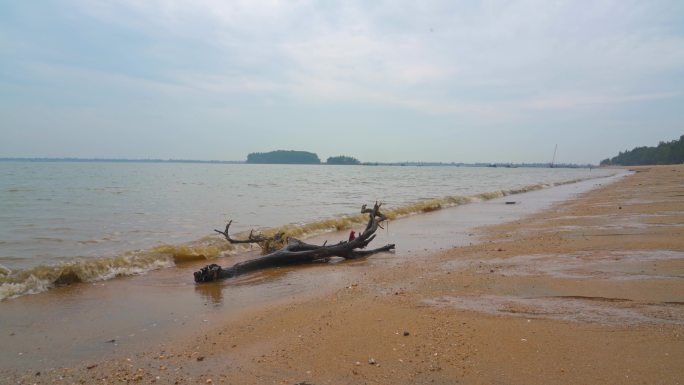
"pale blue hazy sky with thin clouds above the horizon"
0,0,684,163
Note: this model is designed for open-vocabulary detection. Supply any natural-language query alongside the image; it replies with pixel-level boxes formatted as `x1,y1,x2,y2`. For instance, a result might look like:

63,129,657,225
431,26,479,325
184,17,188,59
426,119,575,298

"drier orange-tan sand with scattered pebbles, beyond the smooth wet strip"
4,166,684,384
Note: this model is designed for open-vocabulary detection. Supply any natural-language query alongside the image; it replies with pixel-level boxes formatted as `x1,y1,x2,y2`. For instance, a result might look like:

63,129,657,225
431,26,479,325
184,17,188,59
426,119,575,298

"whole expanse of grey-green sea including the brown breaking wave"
0,161,616,300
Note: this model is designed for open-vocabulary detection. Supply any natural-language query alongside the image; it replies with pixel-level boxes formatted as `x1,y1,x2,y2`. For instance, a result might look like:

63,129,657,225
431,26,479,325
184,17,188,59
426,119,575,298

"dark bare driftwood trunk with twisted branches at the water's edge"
194,202,394,282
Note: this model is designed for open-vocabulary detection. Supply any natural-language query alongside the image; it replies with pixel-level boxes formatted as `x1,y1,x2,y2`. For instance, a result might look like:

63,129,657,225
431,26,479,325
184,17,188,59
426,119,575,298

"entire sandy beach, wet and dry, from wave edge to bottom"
0,166,684,384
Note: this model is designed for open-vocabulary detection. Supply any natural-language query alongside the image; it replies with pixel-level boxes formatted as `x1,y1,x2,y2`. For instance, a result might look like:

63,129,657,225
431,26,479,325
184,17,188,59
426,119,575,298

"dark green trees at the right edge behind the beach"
601,135,684,166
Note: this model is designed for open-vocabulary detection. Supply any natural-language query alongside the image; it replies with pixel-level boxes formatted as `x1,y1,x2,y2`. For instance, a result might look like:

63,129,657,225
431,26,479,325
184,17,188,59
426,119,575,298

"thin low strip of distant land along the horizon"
0,158,599,168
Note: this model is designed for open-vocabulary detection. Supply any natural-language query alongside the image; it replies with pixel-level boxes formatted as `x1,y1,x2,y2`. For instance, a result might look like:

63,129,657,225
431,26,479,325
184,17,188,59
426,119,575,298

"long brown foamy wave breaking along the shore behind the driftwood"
0,178,604,301
